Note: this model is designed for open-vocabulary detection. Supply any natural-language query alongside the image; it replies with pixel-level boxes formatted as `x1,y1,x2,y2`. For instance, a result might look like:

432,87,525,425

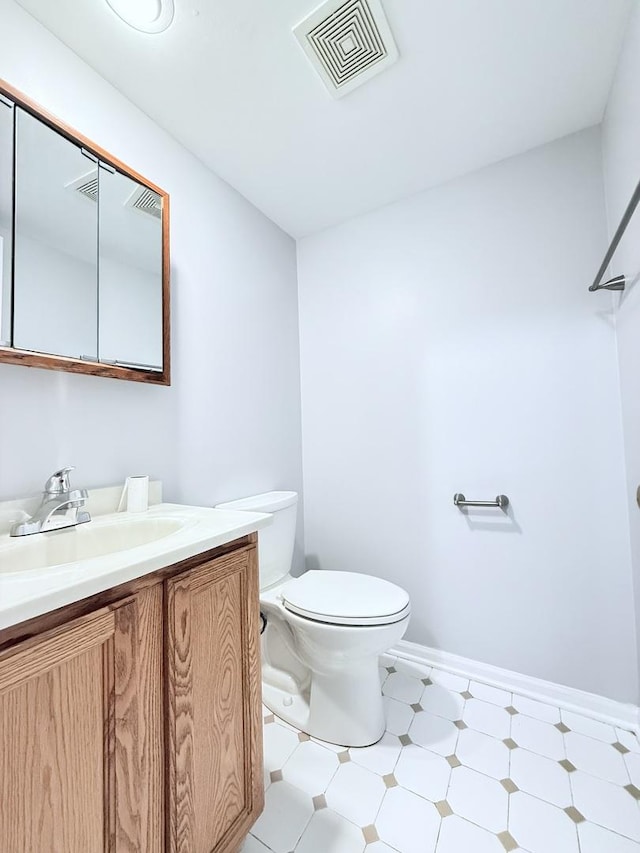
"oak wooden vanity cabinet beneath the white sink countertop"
0,536,263,853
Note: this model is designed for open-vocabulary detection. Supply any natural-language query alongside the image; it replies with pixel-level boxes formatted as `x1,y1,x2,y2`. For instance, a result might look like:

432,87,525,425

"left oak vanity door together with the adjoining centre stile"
0,585,163,853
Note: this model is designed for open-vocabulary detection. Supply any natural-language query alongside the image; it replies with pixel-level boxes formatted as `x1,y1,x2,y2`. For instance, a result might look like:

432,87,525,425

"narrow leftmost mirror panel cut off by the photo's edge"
0,96,13,345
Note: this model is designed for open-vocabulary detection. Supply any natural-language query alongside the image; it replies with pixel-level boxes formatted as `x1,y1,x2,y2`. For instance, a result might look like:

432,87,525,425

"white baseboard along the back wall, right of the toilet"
389,640,640,734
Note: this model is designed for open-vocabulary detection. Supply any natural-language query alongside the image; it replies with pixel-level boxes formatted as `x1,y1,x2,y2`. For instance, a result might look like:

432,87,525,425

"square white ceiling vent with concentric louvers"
293,0,398,98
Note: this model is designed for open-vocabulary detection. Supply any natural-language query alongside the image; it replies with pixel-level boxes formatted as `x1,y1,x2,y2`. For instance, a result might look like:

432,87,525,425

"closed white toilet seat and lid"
280,571,411,626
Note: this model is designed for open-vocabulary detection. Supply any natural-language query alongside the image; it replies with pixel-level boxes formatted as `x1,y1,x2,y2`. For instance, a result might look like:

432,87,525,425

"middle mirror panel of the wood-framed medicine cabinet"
13,109,98,361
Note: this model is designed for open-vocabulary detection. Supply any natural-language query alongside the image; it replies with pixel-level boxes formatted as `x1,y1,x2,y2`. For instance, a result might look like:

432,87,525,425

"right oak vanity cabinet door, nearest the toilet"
166,547,264,853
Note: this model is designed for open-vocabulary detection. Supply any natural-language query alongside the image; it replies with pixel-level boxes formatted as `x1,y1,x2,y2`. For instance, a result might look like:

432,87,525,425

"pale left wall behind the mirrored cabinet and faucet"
0,0,301,564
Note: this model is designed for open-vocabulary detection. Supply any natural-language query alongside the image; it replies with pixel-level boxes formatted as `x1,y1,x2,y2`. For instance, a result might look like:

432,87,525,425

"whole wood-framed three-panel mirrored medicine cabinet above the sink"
0,81,170,385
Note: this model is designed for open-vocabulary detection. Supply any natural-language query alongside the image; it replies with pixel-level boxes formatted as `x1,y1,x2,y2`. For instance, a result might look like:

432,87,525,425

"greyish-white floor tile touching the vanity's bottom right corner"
251,782,313,853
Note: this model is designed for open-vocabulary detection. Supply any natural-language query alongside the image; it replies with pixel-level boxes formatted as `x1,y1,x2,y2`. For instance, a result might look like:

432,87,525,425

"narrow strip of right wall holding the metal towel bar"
601,4,640,704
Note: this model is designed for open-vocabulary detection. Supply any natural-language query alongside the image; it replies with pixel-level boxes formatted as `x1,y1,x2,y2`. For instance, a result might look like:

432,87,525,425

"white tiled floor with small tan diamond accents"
243,655,640,853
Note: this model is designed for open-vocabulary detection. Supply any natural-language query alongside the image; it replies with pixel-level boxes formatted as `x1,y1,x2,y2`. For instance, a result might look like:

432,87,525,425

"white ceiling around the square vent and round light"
12,0,635,237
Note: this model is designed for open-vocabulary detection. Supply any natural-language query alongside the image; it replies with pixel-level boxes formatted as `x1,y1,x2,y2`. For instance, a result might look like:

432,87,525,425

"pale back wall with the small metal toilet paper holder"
298,125,637,701
